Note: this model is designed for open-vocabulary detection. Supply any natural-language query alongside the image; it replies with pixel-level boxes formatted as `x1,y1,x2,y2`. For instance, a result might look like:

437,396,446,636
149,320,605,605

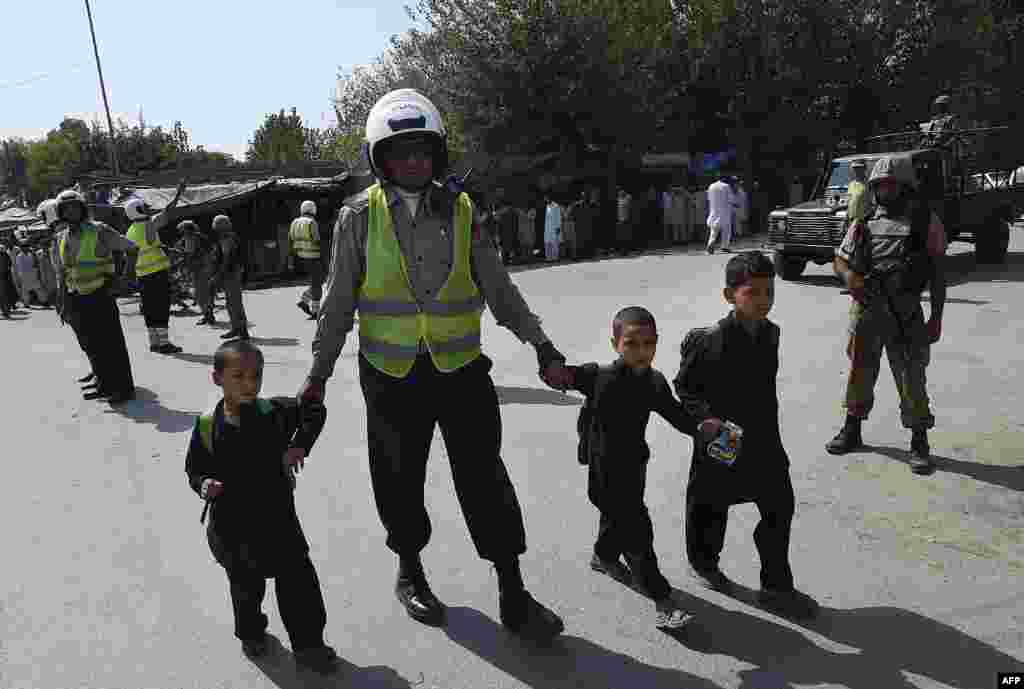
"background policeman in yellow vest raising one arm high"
125,180,185,354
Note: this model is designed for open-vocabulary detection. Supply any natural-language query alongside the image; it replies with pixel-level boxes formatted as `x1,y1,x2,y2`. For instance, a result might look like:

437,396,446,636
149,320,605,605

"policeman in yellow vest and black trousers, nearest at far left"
53,189,138,404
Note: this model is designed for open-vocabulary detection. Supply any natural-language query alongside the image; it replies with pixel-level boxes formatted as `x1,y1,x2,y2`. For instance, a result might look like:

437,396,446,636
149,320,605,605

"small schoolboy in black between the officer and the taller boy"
569,306,695,630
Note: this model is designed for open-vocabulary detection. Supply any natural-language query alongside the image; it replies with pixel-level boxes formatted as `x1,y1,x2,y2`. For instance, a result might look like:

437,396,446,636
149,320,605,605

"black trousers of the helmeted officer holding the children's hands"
359,354,526,562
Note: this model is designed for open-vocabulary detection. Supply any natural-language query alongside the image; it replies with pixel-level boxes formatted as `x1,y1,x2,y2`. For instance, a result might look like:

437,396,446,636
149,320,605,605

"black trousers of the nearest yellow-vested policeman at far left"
69,289,135,393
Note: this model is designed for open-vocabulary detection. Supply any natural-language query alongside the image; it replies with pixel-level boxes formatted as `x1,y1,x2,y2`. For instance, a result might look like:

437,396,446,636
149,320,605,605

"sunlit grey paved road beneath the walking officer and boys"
0,231,1024,689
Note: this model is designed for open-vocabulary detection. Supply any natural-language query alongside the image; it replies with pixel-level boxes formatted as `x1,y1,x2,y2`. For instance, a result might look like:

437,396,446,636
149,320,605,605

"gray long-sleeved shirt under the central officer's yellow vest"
309,181,548,379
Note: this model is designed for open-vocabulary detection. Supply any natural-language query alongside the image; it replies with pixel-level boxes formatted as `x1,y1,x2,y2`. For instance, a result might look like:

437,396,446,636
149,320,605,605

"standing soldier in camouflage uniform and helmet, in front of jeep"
825,156,946,474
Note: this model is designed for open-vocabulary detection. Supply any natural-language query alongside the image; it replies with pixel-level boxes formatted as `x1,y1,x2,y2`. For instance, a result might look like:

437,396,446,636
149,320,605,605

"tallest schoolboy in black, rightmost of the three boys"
675,251,817,617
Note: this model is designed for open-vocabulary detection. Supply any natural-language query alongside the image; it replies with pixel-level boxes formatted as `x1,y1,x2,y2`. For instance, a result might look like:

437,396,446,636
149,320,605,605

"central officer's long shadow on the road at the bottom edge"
443,607,724,689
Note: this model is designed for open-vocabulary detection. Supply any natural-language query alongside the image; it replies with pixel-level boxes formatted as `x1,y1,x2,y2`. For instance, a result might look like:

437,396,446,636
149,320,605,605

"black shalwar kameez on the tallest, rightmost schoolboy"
675,313,795,591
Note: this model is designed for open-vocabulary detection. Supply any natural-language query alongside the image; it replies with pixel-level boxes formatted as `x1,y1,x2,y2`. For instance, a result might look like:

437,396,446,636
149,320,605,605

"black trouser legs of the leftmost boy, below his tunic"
224,555,327,651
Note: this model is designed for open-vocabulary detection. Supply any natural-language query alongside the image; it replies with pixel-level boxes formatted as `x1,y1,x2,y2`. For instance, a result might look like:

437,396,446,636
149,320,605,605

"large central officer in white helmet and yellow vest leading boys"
299,89,568,638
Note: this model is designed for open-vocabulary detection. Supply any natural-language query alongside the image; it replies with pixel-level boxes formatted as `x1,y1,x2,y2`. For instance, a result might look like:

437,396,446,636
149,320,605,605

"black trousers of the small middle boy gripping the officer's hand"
587,458,672,599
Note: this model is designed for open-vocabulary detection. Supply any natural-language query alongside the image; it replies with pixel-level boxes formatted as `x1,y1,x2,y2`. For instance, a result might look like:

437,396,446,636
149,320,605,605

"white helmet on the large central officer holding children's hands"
367,88,447,178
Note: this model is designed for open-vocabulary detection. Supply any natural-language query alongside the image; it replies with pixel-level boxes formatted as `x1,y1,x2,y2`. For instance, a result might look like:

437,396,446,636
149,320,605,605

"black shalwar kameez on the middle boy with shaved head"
569,359,695,599
